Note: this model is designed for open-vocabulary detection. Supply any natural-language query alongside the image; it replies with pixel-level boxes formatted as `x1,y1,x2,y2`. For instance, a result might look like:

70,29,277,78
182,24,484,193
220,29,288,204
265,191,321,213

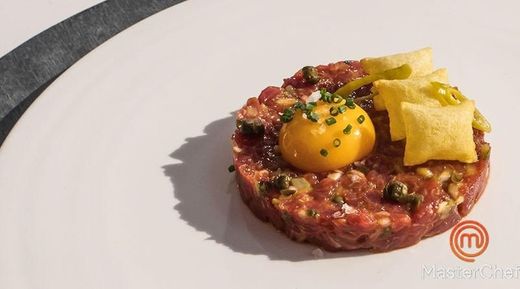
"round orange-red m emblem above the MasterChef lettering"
450,220,489,262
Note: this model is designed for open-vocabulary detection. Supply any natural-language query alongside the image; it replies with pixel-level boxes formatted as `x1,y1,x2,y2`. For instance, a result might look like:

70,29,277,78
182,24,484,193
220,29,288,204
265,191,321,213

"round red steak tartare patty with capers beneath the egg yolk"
232,61,490,251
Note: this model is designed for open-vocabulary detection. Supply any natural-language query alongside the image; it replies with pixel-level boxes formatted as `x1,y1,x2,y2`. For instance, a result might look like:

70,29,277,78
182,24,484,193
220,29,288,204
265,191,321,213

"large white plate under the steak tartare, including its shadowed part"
0,0,520,288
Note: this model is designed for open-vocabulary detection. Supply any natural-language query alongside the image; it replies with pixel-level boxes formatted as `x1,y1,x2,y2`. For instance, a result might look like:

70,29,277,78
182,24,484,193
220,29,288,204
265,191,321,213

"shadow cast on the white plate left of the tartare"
163,116,370,261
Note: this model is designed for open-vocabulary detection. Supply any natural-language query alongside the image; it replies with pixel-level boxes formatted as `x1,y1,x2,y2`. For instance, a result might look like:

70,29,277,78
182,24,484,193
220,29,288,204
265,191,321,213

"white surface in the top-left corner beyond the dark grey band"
0,0,103,57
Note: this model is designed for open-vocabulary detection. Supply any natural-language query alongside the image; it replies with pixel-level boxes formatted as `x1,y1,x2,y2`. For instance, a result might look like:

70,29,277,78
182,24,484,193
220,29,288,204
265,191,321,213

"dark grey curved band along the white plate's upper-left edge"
0,0,184,145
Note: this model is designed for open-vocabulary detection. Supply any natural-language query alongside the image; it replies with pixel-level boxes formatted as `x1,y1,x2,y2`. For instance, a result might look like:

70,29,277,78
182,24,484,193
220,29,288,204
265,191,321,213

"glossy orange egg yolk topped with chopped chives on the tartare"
279,101,376,172
